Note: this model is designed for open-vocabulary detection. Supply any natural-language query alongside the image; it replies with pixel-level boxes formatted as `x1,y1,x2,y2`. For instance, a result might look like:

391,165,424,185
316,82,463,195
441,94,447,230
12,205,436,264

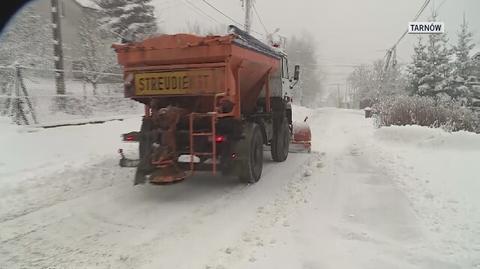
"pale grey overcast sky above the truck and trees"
153,0,480,91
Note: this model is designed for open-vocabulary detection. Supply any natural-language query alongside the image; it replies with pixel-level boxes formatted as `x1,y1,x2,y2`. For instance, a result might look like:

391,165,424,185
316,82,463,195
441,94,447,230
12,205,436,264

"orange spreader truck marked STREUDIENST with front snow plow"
113,26,310,184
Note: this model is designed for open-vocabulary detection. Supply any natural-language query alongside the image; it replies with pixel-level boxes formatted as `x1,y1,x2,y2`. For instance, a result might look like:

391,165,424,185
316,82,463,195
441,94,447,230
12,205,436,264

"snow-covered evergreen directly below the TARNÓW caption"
418,29,452,97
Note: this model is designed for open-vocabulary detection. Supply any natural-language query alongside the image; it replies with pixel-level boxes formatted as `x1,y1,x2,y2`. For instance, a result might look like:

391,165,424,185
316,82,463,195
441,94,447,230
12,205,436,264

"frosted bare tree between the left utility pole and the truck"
80,16,116,95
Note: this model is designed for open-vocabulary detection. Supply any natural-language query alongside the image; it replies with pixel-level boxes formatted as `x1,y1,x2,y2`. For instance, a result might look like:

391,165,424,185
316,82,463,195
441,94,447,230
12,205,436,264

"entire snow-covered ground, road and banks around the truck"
0,107,480,269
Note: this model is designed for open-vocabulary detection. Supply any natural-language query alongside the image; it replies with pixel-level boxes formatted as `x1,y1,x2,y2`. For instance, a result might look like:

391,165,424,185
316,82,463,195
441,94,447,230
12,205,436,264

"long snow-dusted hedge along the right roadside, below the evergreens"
373,96,480,133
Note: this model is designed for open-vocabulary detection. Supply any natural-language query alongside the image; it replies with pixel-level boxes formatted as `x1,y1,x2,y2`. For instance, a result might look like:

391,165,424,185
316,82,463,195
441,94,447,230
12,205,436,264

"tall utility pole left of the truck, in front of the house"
51,0,65,95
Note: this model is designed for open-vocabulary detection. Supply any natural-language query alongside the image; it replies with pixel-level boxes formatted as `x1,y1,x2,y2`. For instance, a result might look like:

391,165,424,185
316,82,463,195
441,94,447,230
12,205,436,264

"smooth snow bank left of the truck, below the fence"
0,116,141,184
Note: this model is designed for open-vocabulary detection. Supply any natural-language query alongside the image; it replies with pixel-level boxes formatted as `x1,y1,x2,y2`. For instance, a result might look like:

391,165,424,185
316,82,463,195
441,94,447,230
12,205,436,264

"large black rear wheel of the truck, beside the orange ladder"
237,123,263,183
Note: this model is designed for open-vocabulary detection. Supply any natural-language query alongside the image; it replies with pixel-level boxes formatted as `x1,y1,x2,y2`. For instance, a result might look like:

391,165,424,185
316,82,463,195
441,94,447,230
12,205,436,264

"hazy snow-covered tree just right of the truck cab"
287,32,322,106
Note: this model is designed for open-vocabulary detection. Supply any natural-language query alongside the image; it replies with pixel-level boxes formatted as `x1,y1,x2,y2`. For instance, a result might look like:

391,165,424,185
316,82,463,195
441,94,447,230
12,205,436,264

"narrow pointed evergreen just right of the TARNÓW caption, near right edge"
450,18,475,101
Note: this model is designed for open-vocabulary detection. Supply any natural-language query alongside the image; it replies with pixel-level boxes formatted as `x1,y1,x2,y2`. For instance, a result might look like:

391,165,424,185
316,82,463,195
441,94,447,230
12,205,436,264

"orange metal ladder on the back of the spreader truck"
189,112,218,175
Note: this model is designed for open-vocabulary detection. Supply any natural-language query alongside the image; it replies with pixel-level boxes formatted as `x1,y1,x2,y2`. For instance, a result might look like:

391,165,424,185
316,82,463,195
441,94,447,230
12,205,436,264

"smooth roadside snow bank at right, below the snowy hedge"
373,123,480,268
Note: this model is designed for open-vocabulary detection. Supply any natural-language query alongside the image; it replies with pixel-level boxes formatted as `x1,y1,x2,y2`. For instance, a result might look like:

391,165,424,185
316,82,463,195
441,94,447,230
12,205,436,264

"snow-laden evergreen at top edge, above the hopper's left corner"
96,0,158,40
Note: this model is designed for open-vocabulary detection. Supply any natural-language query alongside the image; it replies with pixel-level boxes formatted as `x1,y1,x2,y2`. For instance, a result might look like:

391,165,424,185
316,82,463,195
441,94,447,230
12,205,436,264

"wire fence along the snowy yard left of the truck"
0,66,143,125
